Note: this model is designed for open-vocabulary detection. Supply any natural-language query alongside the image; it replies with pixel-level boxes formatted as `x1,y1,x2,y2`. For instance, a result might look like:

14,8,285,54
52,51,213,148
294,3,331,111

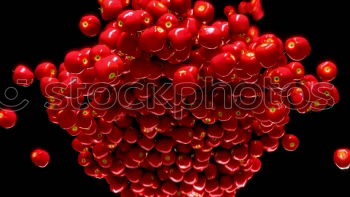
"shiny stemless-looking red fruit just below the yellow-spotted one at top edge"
198,26,222,49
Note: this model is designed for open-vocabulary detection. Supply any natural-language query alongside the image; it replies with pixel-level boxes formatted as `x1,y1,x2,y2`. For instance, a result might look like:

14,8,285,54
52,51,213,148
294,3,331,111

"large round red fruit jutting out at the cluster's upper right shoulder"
285,36,311,61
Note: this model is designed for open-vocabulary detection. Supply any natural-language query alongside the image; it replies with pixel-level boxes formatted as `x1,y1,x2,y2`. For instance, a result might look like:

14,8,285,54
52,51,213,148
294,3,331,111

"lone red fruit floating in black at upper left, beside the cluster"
79,15,101,37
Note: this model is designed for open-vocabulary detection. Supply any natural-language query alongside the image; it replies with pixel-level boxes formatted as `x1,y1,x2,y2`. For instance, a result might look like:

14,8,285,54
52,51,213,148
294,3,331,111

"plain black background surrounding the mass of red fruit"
0,0,350,197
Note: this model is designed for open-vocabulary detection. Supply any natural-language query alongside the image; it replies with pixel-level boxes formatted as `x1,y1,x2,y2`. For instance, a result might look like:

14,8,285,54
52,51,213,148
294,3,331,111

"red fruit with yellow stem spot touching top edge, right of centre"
193,1,215,24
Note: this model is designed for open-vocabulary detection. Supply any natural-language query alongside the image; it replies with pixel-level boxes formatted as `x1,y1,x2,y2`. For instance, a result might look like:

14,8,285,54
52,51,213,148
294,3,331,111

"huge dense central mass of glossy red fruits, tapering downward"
5,0,339,196
